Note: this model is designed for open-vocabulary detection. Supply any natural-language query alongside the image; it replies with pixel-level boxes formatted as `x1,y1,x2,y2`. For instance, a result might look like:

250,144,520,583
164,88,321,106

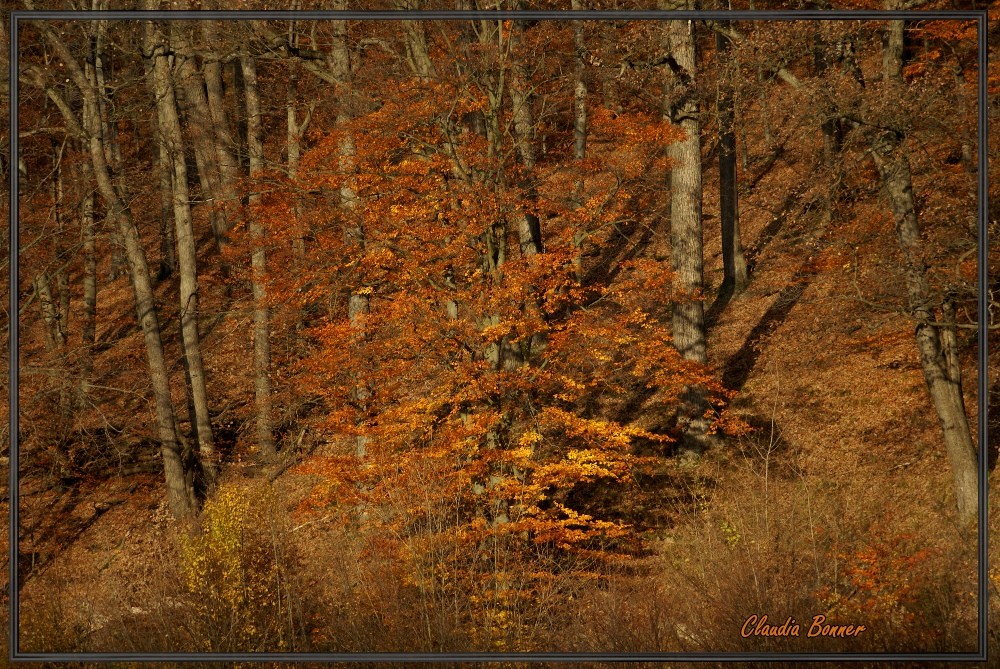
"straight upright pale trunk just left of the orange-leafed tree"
240,53,275,460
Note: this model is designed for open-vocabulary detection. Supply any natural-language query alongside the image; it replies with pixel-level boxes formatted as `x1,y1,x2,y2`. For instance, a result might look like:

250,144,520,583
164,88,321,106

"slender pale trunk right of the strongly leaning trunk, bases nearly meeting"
146,23,217,488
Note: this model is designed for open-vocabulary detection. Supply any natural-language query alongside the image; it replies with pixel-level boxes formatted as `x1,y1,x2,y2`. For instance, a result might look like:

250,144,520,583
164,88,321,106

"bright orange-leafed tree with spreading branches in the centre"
249,28,744,642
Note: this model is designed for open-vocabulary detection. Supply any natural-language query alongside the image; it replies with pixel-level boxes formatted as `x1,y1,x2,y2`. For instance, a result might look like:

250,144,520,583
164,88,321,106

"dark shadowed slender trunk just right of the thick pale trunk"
715,26,748,296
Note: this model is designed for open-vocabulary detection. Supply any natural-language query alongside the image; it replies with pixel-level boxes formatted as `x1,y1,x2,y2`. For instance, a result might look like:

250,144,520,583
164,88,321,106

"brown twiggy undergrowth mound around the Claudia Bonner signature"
574,446,976,666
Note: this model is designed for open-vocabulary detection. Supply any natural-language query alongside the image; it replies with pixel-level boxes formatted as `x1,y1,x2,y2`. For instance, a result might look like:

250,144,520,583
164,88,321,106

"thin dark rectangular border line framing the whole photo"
8,10,989,662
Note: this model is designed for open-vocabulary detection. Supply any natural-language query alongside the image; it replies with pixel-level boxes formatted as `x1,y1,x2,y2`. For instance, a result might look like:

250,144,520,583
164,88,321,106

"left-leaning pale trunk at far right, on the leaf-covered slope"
872,21,979,526
